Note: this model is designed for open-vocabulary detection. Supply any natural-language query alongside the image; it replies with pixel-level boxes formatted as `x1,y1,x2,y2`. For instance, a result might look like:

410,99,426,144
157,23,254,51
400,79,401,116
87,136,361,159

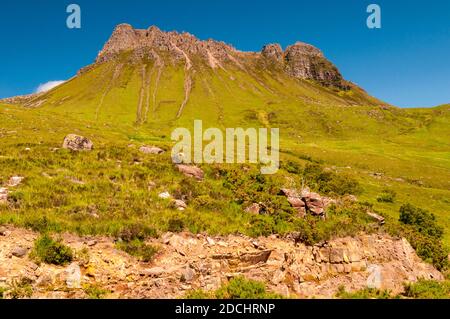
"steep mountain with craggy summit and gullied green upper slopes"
3,24,386,132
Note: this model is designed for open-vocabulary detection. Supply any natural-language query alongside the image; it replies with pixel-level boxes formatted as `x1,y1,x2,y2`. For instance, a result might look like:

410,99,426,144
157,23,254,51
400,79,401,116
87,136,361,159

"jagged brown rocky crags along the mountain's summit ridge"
96,24,349,90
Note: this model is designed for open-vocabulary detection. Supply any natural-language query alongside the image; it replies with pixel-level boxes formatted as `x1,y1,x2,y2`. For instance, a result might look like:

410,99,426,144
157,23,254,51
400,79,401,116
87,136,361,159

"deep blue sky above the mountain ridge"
0,0,450,107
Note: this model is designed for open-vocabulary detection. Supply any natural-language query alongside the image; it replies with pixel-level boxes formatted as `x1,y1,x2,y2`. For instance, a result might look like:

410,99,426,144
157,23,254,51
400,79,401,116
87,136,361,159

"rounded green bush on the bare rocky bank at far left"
31,234,73,265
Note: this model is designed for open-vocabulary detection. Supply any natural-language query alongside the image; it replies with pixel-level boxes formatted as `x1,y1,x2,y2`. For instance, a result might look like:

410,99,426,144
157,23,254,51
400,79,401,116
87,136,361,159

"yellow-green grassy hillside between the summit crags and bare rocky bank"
0,54,450,255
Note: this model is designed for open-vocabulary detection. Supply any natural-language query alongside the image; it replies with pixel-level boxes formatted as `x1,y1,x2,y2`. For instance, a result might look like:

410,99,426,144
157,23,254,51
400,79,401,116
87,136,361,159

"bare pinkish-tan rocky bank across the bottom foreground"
0,227,443,298
